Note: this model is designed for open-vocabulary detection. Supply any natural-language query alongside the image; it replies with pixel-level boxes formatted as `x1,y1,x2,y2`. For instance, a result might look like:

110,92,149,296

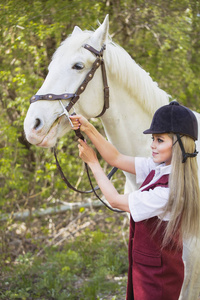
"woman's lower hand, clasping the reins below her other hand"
78,139,98,165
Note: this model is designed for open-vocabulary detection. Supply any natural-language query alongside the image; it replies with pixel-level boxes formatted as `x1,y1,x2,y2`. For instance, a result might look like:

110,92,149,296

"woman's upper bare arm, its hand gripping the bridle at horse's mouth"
70,115,135,174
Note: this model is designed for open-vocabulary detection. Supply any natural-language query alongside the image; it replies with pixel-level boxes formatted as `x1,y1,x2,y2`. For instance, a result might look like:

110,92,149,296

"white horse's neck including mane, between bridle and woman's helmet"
101,44,169,155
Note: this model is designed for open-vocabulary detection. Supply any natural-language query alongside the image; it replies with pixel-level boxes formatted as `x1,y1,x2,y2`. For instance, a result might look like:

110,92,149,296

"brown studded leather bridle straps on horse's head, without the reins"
30,44,109,118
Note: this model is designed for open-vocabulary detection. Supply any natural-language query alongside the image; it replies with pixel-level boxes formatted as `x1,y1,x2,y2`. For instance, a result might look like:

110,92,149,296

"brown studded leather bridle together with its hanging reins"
30,44,124,213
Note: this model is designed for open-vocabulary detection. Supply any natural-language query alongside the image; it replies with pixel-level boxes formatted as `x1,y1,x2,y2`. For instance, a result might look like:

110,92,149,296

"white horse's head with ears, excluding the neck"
24,16,109,148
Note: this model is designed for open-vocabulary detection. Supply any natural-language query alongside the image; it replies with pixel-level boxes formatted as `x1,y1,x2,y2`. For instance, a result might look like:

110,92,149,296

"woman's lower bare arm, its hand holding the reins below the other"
78,139,130,212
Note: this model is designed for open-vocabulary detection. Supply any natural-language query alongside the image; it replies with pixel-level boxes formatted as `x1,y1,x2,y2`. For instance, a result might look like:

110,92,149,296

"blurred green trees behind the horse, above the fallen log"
0,0,200,221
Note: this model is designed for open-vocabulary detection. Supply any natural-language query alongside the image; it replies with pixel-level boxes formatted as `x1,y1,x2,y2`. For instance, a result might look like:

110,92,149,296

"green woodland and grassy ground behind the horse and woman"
0,0,200,300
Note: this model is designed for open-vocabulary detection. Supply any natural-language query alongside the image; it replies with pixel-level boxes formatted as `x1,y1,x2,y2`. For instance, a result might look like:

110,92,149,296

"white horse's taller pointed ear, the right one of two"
91,15,109,47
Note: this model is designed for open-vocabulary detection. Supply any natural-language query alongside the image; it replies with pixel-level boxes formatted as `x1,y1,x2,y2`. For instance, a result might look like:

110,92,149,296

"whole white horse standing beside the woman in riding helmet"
24,16,200,300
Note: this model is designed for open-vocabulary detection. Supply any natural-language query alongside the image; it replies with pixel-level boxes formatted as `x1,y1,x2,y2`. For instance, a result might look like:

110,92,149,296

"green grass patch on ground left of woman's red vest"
0,230,127,300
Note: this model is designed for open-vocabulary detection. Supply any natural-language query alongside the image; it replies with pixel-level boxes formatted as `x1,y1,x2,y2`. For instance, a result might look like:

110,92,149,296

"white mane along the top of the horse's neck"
107,39,170,115
